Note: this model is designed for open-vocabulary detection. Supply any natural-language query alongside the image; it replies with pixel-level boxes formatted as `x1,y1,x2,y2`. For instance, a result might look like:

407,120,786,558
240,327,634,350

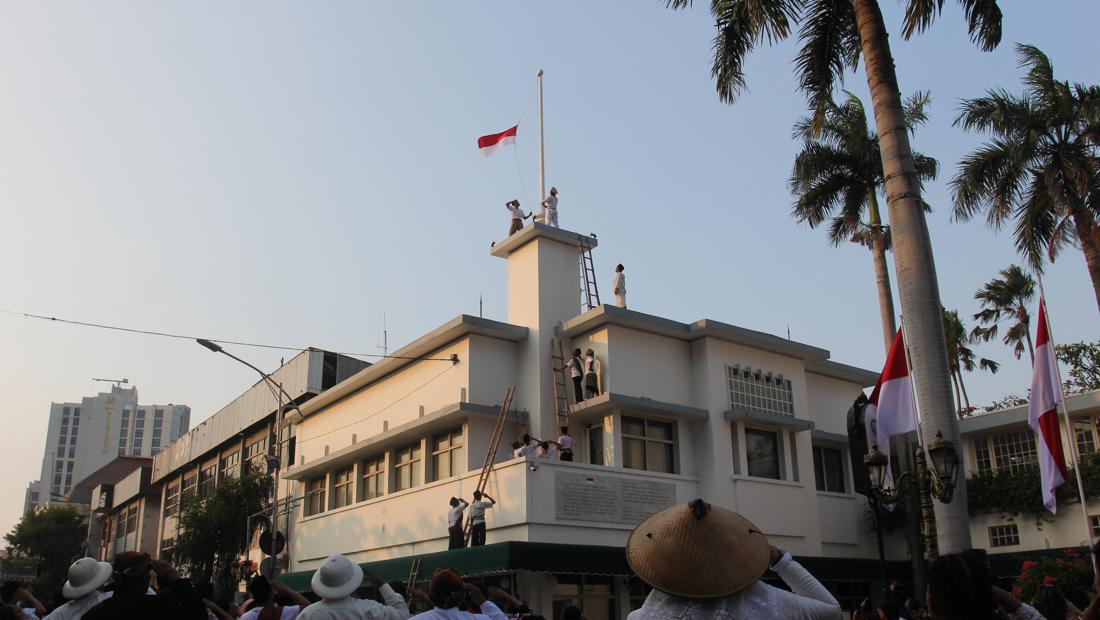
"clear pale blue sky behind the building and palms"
0,0,1100,532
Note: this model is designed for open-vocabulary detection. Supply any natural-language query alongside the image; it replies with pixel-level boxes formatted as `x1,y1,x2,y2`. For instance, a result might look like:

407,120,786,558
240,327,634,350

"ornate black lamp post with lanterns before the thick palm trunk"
864,432,959,574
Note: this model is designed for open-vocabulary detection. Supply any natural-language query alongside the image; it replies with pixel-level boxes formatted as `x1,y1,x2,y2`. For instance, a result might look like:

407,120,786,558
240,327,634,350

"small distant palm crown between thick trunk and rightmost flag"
970,265,1035,364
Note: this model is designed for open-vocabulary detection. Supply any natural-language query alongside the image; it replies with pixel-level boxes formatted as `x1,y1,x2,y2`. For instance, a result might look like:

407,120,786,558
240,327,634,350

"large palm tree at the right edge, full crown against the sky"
952,45,1100,308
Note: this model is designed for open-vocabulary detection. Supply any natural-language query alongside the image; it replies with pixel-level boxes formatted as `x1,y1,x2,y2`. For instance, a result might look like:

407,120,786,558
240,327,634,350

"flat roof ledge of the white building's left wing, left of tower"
287,314,527,423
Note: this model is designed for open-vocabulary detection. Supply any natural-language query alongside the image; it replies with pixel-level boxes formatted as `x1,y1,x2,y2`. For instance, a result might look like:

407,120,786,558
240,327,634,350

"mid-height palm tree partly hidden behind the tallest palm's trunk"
790,92,938,352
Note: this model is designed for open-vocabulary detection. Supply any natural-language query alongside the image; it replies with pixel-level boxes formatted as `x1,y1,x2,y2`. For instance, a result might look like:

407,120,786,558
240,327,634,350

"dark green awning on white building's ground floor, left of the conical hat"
277,541,631,593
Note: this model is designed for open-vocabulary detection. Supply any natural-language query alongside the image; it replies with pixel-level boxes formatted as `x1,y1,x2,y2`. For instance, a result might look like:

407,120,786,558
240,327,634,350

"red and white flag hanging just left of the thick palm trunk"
865,330,916,481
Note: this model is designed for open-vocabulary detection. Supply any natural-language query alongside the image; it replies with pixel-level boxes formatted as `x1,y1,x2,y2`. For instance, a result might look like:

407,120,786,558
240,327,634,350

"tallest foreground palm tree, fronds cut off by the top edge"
666,0,1001,553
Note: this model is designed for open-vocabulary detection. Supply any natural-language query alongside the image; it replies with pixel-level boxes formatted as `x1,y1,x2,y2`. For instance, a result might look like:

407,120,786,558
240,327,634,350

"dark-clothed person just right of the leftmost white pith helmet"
84,551,208,620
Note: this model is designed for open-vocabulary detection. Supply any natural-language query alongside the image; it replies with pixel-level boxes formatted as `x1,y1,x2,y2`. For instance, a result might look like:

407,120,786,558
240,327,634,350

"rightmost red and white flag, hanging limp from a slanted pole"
1027,297,1068,512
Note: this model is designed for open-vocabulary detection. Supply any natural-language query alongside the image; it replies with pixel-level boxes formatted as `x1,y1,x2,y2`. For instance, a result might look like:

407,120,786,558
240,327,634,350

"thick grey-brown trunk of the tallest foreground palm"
854,0,972,554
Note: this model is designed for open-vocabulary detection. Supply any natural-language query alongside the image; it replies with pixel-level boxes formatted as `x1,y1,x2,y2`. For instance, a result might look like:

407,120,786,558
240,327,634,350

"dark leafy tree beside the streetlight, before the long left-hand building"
173,470,272,593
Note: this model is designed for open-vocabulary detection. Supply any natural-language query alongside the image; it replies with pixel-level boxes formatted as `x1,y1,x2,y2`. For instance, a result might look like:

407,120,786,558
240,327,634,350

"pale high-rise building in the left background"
37,386,191,506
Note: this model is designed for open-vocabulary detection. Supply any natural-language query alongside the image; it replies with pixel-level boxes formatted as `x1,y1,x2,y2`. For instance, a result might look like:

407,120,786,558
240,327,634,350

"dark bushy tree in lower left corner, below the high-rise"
4,506,88,593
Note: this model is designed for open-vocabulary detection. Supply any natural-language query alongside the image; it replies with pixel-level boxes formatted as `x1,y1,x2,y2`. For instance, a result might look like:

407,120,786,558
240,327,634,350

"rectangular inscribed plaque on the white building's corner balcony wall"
554,472,677,525
